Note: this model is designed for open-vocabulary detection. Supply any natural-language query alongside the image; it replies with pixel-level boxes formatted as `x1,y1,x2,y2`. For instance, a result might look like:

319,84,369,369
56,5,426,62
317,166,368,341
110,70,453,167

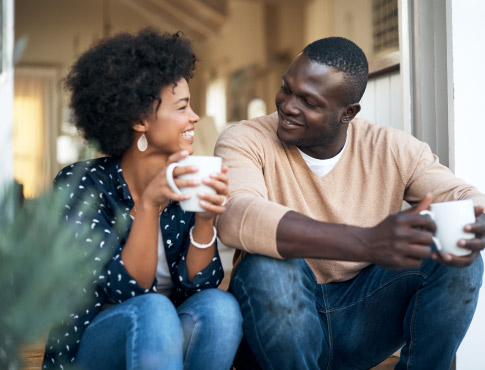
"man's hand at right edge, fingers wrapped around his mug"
431,206,485,267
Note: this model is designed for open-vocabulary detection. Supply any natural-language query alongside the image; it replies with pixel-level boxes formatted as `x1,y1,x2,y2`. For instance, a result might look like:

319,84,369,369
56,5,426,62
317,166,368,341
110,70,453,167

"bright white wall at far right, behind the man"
447,0,485,370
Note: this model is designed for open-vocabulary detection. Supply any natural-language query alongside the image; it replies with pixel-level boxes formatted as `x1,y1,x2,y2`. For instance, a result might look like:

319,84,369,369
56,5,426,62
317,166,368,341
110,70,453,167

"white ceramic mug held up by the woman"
165,155,222,212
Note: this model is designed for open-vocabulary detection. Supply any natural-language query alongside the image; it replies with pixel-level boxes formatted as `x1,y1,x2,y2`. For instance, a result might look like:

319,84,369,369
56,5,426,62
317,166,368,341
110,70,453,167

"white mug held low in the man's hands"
420,199,475,256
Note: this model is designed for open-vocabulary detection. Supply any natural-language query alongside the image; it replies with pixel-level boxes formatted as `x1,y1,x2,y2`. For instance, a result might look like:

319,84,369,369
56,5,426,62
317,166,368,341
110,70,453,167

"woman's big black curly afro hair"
64,28,197,156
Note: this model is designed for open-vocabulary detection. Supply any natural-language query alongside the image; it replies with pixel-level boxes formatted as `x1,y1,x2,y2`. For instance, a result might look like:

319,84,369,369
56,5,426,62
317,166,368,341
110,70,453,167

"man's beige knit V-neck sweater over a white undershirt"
215,113,485,283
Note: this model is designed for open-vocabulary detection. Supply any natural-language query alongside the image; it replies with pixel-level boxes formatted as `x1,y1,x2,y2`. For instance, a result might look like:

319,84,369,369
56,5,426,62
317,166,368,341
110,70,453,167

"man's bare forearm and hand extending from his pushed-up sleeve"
276,196,435,269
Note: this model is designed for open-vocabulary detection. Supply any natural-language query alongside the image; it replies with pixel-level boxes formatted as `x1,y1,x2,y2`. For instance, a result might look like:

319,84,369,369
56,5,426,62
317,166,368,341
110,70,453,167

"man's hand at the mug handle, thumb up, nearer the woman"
359,194,436,269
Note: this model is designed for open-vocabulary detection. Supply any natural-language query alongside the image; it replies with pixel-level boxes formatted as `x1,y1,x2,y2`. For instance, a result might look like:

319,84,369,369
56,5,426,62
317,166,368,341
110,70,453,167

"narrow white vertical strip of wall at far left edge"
0,0,14,189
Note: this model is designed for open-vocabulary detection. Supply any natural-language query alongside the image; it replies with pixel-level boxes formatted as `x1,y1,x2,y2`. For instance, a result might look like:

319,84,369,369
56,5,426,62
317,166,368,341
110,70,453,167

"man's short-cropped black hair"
303,37,369,106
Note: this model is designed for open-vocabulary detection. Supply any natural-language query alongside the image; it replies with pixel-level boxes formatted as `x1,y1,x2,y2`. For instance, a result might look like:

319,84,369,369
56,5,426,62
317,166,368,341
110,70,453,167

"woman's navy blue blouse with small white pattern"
43,157,224,369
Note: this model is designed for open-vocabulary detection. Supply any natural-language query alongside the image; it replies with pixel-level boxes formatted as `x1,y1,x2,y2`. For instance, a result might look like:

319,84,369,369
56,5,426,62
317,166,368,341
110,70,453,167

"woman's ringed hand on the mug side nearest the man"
196,166,229,219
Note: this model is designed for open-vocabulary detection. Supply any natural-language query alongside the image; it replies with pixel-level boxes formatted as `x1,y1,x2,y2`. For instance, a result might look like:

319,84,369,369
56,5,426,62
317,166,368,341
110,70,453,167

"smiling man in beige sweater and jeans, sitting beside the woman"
216,38,485,370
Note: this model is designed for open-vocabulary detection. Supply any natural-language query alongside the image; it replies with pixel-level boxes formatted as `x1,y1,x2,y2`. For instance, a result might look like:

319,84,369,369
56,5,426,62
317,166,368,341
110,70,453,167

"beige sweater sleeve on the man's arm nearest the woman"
215,124,290,258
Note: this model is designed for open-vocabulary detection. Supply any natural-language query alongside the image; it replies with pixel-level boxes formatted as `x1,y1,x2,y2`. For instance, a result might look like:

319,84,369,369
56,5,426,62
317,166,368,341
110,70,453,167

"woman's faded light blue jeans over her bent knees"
76,289,242,370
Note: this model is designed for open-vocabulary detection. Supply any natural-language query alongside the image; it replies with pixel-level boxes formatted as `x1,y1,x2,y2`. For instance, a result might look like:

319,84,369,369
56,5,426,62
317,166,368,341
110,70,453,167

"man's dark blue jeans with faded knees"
229,255,483,370
